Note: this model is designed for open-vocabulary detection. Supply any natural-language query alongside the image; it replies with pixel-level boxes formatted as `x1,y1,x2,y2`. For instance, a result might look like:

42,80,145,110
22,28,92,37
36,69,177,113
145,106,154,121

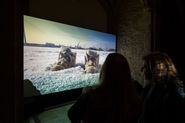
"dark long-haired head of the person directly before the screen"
100,53,131,88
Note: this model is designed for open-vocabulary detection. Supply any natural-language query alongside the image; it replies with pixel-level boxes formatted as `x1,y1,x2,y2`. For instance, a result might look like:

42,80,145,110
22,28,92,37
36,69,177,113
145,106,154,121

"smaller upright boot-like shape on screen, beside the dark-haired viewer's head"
85,50,99,73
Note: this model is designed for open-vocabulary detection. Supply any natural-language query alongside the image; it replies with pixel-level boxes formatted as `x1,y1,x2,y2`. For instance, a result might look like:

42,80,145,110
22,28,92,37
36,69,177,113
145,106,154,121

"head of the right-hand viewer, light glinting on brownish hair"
143,52,177,82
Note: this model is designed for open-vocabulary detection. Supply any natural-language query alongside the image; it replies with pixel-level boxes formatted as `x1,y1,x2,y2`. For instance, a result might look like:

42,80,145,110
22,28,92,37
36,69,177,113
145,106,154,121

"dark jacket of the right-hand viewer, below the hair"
139,80,185,123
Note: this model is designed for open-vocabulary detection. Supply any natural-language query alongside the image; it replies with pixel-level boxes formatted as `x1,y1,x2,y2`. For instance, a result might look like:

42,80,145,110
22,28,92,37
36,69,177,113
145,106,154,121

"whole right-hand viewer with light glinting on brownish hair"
139,52,185,123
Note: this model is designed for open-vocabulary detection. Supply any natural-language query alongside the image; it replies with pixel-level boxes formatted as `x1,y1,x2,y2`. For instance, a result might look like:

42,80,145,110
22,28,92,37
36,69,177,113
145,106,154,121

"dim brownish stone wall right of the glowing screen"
117,0,151,84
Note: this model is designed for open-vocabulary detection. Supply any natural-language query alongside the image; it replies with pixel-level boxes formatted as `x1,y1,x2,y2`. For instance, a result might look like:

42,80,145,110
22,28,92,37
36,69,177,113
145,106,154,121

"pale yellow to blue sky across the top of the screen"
24,15,116,49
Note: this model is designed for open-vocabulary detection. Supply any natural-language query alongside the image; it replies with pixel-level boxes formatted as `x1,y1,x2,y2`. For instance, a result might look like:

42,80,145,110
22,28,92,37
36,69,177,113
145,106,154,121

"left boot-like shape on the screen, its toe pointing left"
51,47,76,71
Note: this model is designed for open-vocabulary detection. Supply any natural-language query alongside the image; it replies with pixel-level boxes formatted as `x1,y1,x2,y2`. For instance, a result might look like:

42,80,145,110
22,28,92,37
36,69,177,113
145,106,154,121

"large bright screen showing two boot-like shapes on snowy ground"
23,15,116,95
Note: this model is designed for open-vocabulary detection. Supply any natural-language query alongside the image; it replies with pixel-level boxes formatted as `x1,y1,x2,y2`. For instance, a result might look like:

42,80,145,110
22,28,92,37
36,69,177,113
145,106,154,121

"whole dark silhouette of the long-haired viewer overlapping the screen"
68,53,142,123
